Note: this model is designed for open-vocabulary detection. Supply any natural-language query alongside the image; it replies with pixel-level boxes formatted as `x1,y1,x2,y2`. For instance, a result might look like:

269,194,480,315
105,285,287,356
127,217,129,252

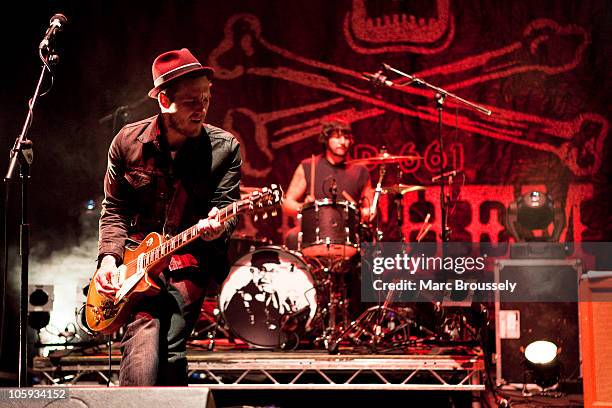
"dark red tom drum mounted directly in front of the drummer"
298,199,359,259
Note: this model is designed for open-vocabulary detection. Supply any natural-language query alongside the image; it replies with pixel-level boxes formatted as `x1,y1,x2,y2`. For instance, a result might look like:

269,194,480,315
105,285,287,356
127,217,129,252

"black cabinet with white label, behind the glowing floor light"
494,259,582,385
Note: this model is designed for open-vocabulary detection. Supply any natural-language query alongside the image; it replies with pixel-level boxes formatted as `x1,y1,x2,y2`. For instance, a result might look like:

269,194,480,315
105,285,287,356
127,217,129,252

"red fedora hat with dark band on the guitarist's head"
149,48,215,98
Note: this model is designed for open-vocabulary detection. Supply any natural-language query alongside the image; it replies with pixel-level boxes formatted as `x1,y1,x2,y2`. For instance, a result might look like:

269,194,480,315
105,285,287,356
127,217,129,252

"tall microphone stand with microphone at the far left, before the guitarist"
4,48,59,387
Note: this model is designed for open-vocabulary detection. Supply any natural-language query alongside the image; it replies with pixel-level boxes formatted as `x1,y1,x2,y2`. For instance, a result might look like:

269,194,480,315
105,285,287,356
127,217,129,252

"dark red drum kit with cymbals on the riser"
213,152,462,353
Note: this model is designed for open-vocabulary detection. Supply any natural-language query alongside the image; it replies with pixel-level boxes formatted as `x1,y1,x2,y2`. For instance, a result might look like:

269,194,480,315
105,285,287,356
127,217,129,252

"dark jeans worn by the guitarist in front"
119,268,207,385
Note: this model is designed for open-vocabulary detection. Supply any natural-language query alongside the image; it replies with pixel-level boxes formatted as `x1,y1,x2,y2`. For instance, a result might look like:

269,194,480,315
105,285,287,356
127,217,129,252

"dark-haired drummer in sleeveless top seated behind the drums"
283,117,375,249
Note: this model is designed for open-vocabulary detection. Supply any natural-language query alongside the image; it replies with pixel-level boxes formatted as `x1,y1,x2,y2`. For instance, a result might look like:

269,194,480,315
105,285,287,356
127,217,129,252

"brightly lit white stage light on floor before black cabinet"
523,340,561,390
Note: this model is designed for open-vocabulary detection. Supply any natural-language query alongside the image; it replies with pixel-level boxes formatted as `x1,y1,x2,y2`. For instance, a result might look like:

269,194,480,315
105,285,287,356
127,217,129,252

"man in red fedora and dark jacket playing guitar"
93,48,242,385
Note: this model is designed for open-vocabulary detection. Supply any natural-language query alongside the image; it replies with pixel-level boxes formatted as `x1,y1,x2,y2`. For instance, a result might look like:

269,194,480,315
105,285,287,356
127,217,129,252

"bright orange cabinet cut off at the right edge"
579,271,612,408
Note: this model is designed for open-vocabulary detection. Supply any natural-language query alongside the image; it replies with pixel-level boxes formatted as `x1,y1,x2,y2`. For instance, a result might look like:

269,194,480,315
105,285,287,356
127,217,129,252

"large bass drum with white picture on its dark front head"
219,246,317,348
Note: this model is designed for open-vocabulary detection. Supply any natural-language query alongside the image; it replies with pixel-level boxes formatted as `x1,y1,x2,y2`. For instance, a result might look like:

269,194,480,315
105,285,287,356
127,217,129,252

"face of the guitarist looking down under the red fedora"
160,76,211,137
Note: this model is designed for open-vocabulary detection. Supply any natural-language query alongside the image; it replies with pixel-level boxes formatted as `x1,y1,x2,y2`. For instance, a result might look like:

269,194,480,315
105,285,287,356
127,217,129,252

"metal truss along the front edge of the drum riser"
34,351,485,391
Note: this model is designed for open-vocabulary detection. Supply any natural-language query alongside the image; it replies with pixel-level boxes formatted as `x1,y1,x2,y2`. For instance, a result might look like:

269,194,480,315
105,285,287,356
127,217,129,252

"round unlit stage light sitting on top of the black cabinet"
507,191,565,242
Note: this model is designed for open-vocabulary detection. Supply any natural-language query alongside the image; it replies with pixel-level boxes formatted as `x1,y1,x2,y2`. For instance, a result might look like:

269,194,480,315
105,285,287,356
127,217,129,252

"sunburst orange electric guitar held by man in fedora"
85,184,283,334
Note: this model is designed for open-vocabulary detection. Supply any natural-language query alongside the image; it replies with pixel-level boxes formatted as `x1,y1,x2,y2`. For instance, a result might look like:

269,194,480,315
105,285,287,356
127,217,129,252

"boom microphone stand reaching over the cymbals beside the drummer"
378,64,491,242
